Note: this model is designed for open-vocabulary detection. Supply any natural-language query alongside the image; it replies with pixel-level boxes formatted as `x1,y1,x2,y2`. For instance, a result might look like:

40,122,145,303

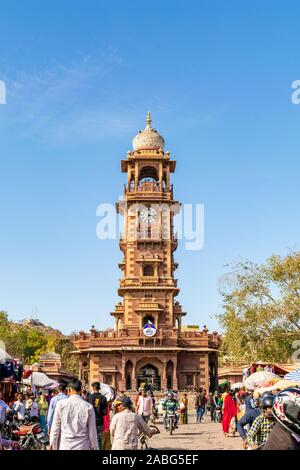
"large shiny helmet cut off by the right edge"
273,388,300,436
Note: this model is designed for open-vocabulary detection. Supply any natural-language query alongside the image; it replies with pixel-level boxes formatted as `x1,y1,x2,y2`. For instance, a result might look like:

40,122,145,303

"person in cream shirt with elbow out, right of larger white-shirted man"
110,397,156,450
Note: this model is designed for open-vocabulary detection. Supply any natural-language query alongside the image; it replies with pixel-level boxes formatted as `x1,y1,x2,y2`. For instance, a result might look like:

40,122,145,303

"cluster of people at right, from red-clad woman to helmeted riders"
217,387,300,450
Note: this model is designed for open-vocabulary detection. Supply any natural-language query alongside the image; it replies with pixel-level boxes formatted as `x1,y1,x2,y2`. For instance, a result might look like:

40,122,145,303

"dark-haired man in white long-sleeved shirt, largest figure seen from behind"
50,380,99,450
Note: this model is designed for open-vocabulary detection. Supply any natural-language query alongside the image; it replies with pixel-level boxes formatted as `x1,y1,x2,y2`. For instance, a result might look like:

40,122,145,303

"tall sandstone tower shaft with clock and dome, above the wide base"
114,113,185,334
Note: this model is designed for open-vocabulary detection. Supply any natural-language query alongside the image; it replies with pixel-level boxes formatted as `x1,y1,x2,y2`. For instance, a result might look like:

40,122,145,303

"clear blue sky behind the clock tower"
0,0,300,332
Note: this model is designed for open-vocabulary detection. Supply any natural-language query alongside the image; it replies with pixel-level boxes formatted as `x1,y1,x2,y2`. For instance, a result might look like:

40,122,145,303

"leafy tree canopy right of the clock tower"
218,252,300,362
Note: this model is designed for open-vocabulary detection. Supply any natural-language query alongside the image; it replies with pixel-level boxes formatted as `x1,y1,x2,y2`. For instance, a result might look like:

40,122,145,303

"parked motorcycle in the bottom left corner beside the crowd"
12,423,49,450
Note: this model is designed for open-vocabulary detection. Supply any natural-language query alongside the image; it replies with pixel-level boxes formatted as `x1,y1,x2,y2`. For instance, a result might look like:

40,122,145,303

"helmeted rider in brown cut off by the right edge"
263,388,300,450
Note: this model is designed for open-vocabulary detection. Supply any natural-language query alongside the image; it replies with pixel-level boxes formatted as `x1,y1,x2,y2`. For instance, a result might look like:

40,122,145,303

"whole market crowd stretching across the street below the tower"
0,381,300,450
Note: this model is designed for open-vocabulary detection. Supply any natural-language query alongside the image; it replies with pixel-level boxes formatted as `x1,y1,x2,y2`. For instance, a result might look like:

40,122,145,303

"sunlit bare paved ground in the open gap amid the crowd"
149,412,243,450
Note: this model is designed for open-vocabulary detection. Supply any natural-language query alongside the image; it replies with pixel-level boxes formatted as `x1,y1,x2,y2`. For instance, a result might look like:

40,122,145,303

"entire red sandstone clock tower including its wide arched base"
74,113,221,391
